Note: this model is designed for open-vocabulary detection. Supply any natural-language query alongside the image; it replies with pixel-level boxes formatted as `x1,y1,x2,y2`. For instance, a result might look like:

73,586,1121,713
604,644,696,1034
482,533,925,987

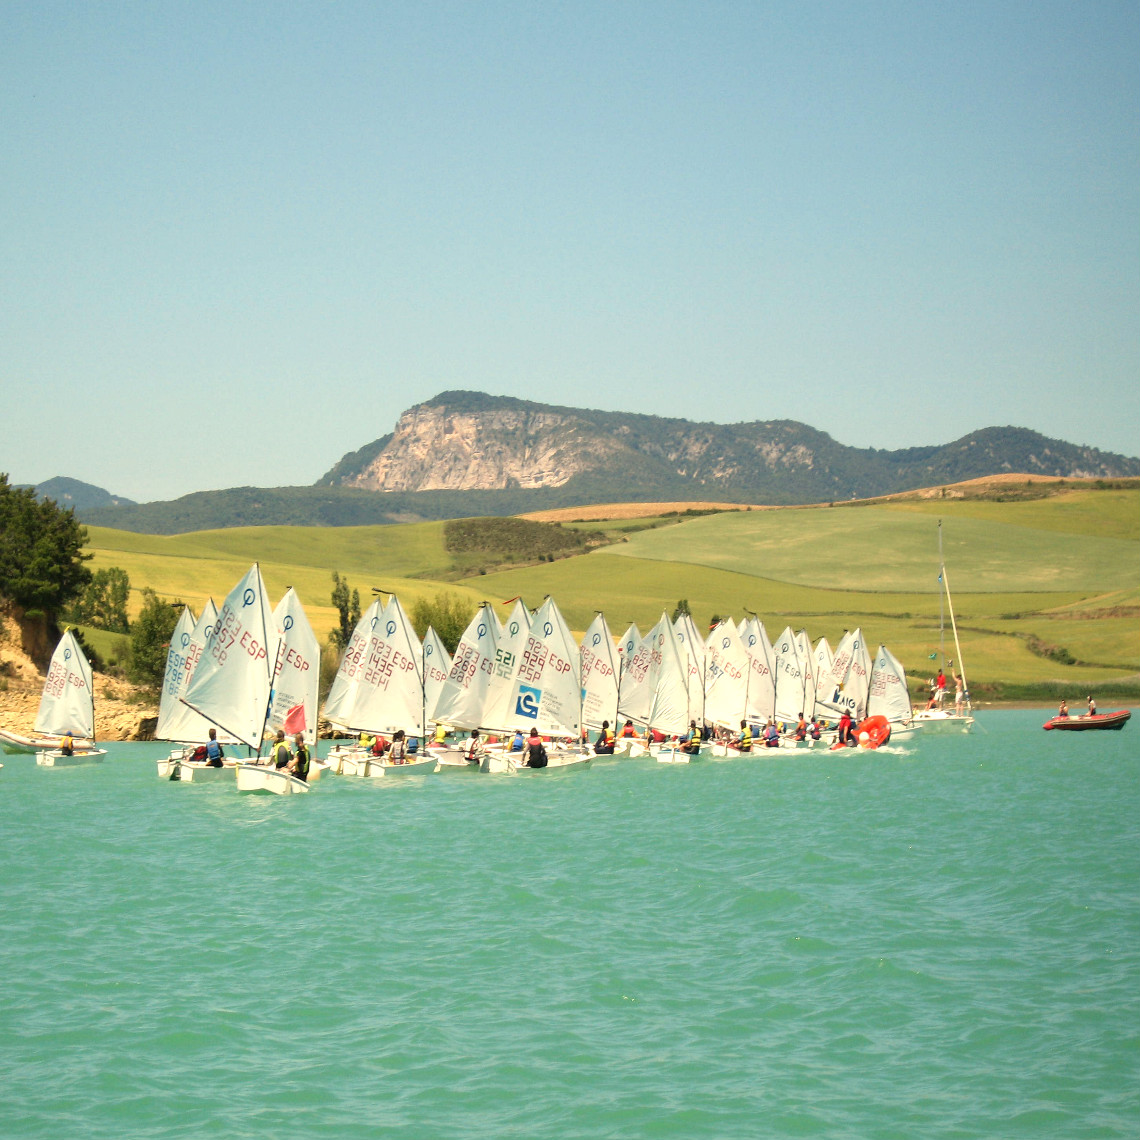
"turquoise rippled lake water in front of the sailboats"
0,713,1140,1140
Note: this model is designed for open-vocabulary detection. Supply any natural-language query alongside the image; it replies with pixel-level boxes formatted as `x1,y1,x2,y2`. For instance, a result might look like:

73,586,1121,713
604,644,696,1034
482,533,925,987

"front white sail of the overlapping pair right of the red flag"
348,594,424,736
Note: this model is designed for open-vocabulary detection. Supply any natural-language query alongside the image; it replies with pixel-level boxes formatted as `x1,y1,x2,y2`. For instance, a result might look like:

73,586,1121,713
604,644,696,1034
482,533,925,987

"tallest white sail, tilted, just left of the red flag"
181,562,277,748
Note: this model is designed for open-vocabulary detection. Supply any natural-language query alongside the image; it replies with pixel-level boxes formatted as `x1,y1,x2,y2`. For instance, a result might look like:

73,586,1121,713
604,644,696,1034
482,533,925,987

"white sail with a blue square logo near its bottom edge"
489,597,581,740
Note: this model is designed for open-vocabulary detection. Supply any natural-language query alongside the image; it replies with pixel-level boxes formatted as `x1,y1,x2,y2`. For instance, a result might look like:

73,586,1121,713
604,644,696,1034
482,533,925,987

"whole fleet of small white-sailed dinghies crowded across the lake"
3,523,974,793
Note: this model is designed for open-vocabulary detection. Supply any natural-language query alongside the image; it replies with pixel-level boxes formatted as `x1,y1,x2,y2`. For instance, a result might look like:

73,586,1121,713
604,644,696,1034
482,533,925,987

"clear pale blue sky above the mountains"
0,0,1140,500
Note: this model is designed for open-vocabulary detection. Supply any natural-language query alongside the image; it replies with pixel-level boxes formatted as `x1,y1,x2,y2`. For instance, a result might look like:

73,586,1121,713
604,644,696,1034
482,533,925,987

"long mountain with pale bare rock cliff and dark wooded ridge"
317,391,1140,504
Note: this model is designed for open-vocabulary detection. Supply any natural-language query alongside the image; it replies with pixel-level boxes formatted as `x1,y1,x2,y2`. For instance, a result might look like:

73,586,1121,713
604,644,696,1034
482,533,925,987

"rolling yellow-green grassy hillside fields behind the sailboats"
82,488,1140,699
